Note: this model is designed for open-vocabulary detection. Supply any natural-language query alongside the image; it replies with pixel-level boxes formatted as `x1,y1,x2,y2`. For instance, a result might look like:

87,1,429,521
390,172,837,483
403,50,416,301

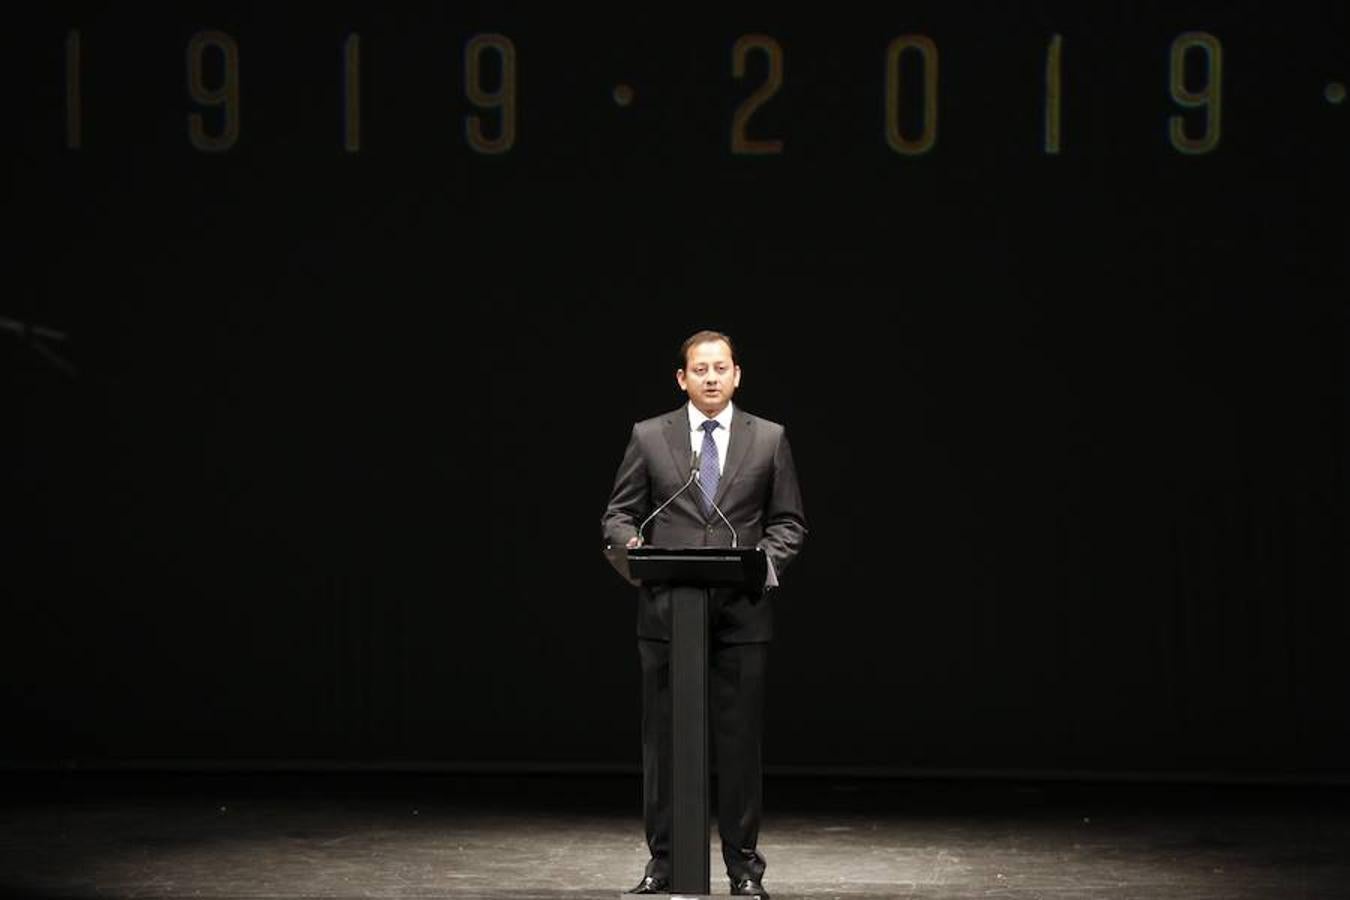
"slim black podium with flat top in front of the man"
605,546,767,897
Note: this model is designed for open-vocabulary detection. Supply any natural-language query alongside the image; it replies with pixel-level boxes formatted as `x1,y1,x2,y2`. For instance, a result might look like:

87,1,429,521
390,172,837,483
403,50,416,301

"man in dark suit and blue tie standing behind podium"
601,331,806,900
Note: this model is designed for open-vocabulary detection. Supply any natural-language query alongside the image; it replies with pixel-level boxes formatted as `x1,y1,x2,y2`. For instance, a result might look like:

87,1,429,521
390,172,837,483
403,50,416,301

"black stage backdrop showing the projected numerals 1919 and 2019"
0,0,1350,777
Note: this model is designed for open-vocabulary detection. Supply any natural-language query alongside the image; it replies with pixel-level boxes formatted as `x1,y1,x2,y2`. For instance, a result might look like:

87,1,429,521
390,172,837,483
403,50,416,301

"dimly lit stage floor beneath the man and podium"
0,773,1350,900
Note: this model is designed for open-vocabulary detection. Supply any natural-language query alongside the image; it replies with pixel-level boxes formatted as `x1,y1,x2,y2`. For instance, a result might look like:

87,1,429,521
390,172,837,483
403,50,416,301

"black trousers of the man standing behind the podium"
637,638,768,881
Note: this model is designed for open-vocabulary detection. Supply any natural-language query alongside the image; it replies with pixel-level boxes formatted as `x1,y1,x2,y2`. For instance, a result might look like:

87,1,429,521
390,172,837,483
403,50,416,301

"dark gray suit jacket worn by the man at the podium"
601,406,806,644
